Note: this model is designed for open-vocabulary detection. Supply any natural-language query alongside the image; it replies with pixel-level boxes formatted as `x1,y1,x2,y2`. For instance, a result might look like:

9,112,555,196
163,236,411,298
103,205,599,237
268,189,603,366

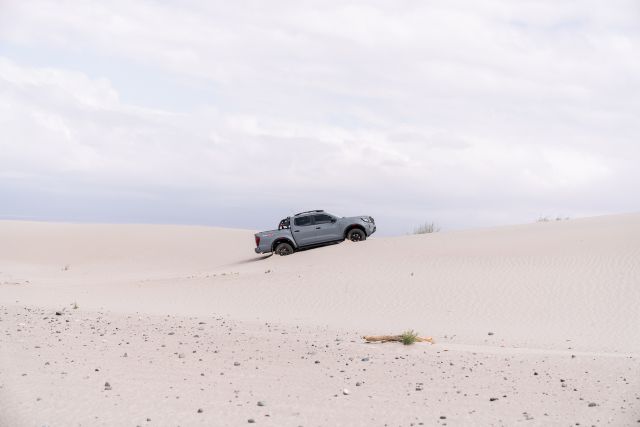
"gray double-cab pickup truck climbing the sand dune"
255,210,376,255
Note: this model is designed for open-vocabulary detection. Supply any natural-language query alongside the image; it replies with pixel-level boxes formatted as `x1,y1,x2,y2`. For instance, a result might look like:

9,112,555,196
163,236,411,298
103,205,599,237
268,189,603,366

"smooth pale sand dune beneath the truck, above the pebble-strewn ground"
0,215,640,352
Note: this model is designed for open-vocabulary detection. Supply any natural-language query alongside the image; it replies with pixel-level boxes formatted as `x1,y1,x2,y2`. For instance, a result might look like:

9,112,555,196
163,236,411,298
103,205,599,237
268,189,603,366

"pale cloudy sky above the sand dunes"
0,0,640,235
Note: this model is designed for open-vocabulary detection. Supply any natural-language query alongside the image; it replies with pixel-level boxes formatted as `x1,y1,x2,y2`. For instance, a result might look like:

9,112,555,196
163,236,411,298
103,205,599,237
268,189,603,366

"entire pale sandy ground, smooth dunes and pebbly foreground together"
0,214,640,426
